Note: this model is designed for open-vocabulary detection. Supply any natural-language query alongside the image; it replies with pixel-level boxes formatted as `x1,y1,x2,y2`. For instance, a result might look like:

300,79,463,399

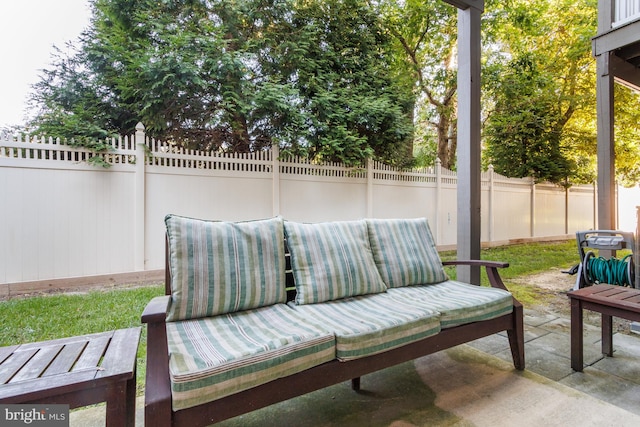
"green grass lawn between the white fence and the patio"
0,240,579,393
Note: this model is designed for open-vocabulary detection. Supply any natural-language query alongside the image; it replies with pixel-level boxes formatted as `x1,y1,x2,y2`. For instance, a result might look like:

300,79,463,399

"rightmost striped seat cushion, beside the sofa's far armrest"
387,280,513,329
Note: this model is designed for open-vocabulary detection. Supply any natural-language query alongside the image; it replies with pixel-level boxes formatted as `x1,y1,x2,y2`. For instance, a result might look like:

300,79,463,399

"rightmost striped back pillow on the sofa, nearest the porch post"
367,218,447,288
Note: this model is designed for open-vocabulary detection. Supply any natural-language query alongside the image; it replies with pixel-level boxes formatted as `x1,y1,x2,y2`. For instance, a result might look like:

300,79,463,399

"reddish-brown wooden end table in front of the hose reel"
567,284,640,372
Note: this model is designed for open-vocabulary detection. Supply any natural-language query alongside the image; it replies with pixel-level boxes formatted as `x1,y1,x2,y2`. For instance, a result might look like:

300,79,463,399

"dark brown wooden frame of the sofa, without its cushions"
142,242,525,427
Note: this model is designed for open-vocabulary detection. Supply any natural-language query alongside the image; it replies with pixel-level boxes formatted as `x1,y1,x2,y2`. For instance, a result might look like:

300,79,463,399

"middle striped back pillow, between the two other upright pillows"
284,221,386,304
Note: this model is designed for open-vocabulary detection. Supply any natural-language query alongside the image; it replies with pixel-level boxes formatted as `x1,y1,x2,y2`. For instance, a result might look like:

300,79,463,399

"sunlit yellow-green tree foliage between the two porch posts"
484,0,597,185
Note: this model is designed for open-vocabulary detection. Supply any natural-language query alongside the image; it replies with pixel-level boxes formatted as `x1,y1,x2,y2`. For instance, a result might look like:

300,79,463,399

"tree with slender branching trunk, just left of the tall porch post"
379,0,457,169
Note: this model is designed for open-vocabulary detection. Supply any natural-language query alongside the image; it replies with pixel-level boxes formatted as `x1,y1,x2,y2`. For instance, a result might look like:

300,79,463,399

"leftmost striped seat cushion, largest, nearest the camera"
167,304,335,410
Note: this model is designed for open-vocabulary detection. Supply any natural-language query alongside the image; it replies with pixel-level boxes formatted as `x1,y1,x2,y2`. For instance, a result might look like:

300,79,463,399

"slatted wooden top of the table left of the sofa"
0,327,141,402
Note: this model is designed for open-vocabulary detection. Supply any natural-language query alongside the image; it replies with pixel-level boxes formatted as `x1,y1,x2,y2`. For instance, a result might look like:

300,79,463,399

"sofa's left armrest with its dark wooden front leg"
141,295,171,426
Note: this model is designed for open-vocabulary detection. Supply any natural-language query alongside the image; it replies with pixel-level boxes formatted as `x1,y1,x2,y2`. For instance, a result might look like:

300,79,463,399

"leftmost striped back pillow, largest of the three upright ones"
165,215,286,321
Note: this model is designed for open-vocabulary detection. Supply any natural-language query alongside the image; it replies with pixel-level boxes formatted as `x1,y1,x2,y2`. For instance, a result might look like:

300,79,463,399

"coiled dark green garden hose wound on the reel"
582,251,634,286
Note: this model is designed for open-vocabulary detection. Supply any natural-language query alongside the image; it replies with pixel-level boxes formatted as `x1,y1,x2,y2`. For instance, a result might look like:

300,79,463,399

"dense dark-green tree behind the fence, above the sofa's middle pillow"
263,0,413,165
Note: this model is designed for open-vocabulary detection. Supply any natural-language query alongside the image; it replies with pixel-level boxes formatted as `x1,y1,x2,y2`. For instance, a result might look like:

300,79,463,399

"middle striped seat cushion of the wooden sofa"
289,293,440,361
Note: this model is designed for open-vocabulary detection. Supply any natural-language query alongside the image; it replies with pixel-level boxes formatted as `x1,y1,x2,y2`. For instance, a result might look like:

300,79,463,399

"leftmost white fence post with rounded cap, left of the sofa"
134,122,146,271
